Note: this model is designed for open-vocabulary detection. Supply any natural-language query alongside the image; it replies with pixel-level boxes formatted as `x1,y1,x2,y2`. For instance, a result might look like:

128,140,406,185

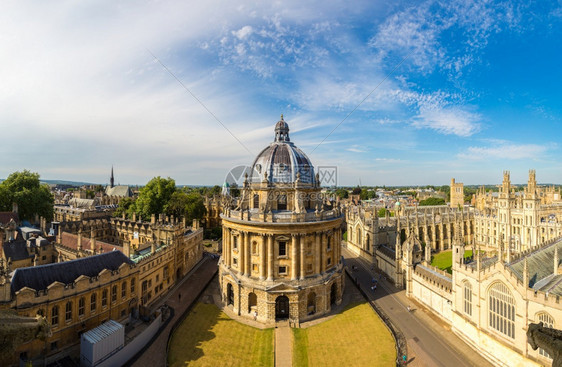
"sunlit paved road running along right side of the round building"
342,248,492,367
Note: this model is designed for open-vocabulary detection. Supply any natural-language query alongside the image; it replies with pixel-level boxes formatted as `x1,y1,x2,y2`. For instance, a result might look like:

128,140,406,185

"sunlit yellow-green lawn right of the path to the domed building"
293,302,396,367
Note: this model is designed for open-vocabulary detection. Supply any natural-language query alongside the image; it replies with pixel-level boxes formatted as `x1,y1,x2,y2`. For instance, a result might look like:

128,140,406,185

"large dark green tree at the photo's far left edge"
0,170,55,221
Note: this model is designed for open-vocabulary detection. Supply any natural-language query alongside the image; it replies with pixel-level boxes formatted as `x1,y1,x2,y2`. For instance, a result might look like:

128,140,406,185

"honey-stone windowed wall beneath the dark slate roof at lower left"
0,253,139,365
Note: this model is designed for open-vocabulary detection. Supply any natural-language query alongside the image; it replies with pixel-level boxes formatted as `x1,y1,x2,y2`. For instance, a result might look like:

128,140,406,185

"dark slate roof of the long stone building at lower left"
11,251,134,293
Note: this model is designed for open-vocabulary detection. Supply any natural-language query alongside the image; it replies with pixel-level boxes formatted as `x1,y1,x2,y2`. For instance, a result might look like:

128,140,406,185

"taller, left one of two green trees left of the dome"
129,176,176,219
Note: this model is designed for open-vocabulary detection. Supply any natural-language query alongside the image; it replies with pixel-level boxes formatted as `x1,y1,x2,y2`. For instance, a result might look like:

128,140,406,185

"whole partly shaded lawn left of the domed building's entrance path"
168,303,274,367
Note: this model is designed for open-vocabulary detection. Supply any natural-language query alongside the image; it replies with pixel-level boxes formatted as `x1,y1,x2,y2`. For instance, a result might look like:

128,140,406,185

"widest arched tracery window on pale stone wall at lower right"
488,283,515,339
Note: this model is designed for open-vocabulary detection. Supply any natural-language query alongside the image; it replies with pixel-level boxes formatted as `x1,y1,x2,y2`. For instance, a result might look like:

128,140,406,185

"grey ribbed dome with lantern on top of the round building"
252,115,315,184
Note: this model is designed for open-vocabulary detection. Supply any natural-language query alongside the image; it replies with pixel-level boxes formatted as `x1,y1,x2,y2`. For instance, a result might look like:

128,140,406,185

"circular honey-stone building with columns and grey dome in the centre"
219,115,344,325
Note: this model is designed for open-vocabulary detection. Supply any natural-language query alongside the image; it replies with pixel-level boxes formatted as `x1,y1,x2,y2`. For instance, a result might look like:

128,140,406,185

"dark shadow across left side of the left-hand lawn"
168,303,220,366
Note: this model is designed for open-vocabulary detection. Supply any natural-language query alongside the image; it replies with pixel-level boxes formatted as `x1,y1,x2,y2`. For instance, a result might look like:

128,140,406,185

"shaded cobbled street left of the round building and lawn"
132,257,217,367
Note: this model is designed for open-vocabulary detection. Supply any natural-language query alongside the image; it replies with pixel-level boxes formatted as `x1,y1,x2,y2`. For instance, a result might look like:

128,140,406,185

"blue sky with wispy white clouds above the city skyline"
0,1,562,185
